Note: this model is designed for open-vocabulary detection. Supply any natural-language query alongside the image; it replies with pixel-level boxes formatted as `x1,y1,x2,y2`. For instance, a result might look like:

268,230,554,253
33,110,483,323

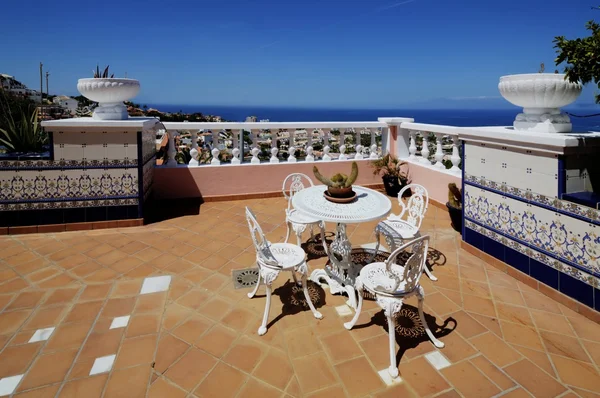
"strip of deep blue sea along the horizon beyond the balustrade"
148,104,600,131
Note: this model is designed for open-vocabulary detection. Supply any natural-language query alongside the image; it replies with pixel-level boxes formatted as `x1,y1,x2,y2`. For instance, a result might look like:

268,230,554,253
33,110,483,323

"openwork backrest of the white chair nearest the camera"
385,235,429,292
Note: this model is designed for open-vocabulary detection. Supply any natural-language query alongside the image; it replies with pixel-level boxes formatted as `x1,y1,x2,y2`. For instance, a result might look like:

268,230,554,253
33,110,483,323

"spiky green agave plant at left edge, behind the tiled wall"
0,107,47,152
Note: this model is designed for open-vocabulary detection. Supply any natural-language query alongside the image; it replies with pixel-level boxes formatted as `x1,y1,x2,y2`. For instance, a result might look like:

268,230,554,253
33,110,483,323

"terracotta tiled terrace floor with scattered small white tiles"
0,199,600,398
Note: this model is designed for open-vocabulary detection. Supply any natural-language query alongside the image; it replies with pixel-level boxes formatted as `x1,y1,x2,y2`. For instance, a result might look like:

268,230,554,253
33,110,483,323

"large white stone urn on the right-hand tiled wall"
498,73,582,133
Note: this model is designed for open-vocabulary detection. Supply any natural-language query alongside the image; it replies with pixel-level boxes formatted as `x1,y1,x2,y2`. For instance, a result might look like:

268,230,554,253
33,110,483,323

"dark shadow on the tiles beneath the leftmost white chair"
267,280,327,328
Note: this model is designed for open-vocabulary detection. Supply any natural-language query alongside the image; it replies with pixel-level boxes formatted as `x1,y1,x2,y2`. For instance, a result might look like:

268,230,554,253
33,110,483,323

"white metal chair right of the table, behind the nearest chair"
371,184,437,281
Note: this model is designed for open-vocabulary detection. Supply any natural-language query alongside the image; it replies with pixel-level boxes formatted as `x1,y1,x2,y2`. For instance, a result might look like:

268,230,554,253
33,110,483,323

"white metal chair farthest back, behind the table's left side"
281,173,327,253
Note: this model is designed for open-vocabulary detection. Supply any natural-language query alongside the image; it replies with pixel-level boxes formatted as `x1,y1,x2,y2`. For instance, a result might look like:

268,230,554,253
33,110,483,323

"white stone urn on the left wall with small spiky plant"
77,78,140,120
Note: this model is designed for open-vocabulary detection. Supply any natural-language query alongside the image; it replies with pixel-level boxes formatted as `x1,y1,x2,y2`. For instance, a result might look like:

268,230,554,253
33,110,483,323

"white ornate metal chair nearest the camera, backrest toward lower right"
344,235,444,378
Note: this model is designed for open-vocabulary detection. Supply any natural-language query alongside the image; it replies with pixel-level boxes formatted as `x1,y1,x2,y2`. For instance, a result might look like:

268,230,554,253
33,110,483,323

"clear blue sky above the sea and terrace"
0,0,600,108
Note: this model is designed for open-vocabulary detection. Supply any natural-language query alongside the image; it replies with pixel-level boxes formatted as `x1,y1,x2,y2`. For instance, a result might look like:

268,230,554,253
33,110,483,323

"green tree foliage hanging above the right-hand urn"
554,21,600,103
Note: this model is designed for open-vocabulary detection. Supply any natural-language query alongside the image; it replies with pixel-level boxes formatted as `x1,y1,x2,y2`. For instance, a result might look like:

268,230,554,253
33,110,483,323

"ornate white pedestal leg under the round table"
310,223,358,308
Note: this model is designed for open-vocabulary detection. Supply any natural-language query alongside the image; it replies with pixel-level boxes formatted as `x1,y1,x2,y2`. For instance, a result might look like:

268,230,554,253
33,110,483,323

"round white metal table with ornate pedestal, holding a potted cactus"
292,185,392,308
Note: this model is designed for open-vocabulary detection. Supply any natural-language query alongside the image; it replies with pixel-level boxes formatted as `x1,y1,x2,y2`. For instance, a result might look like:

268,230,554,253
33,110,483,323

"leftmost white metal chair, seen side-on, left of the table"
246,207,323,336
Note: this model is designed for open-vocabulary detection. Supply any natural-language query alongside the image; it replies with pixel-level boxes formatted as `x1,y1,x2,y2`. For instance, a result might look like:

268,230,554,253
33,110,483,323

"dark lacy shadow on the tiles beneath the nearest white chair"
353,304,458,366
